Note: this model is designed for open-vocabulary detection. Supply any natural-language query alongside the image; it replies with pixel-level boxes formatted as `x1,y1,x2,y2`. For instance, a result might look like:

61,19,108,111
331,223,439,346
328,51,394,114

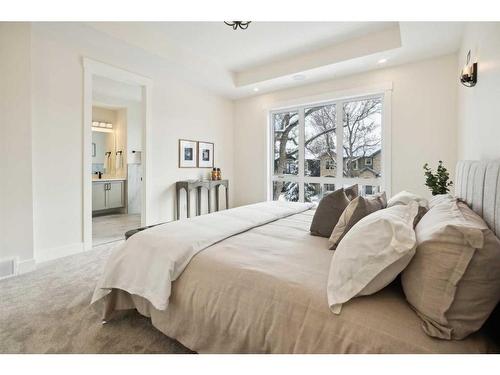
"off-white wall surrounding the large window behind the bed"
234,55,457,205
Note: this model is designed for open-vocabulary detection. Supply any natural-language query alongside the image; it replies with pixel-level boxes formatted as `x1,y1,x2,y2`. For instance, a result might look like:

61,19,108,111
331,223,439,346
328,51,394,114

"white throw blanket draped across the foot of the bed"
92,201,312,310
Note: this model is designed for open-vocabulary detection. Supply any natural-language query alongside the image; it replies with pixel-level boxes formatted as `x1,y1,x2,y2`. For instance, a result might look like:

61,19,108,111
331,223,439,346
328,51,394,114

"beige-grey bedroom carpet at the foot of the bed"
0,243,190,353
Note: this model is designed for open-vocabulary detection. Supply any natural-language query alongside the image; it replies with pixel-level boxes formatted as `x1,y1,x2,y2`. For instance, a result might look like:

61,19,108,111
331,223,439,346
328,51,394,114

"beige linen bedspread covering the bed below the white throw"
99,211,499,353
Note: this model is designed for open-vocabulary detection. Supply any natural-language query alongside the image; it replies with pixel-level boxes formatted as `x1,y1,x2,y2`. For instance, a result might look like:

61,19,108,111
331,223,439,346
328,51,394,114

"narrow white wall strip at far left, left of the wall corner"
0,23,33,271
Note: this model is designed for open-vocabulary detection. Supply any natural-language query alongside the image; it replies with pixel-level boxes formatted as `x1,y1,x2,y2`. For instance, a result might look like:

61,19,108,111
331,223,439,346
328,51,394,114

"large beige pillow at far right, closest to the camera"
401,199,500,340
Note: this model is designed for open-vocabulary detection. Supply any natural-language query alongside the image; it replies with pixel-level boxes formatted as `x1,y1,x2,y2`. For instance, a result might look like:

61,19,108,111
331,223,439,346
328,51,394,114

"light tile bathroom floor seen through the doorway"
92,214,141,246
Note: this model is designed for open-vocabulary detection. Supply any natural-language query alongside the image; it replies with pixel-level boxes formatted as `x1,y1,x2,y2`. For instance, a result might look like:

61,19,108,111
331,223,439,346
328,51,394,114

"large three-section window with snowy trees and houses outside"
270,94,388,202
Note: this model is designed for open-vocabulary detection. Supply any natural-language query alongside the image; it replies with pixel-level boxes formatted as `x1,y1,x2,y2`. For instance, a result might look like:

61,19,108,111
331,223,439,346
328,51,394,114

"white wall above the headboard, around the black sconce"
457,22,500,160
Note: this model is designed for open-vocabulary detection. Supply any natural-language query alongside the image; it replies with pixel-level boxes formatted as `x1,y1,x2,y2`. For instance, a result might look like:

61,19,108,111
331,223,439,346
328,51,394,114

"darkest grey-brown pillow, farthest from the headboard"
309,185,350,237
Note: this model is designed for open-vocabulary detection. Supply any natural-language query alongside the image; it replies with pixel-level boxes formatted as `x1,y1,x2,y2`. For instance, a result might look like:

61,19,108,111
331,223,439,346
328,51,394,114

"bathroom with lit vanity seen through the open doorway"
91,77,143,246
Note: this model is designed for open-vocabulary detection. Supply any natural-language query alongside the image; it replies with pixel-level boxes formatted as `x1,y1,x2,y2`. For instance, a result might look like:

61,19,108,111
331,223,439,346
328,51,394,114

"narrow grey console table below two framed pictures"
175,180,229,220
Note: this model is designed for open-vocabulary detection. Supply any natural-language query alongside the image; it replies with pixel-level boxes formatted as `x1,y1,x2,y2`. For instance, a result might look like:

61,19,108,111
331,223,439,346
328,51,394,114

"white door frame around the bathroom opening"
82,57,153,250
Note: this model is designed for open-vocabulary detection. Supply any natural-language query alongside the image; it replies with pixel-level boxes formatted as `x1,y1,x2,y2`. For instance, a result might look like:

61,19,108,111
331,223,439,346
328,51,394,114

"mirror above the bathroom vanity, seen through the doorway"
92,129,116,175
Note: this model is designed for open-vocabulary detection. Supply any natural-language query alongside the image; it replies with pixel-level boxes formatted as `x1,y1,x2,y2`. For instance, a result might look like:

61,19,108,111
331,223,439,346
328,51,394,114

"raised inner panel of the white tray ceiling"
144,22,395,72
